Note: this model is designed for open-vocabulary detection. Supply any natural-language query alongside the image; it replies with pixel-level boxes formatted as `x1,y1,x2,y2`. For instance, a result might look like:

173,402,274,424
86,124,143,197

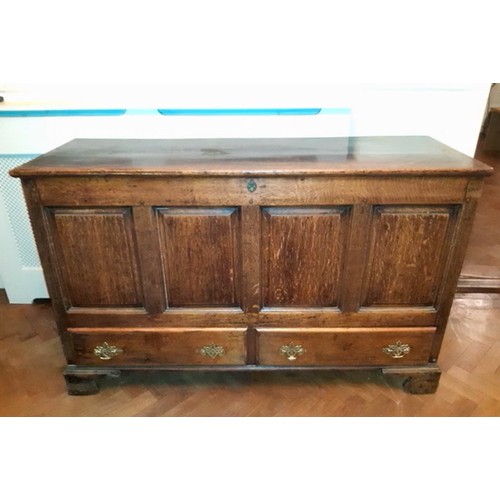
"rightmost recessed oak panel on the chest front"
363,207,453,307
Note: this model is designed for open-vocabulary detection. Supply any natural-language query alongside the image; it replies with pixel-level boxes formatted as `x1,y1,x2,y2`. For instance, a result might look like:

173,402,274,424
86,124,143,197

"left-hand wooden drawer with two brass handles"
68,328,246,366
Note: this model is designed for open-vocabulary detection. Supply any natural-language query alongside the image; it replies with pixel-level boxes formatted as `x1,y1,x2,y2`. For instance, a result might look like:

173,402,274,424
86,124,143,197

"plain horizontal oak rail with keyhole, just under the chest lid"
33,176,468,207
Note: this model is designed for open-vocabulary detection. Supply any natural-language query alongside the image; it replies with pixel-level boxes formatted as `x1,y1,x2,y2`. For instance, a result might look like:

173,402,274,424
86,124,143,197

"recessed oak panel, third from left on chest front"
261,207,349,307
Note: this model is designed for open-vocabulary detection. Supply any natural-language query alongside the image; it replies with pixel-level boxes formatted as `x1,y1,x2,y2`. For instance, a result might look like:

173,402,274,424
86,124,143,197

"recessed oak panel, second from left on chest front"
157,207,240,307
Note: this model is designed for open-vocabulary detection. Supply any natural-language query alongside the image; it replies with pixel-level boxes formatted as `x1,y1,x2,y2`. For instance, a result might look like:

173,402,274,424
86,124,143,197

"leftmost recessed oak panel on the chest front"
48,208,142,307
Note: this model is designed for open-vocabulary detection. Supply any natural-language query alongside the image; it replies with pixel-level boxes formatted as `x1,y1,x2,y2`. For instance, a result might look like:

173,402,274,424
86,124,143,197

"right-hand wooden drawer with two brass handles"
257,328,436,366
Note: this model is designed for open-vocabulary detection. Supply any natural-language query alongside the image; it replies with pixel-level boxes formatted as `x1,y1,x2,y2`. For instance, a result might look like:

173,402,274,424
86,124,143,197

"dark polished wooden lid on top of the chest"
10,136,492,177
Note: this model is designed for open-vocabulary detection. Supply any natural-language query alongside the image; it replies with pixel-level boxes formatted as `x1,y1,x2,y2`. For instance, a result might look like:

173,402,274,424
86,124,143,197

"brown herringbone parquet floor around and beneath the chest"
0,294,500,417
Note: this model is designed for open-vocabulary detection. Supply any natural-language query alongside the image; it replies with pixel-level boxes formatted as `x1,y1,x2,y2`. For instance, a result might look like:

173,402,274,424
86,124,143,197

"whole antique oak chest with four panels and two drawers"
11,137,490,394
